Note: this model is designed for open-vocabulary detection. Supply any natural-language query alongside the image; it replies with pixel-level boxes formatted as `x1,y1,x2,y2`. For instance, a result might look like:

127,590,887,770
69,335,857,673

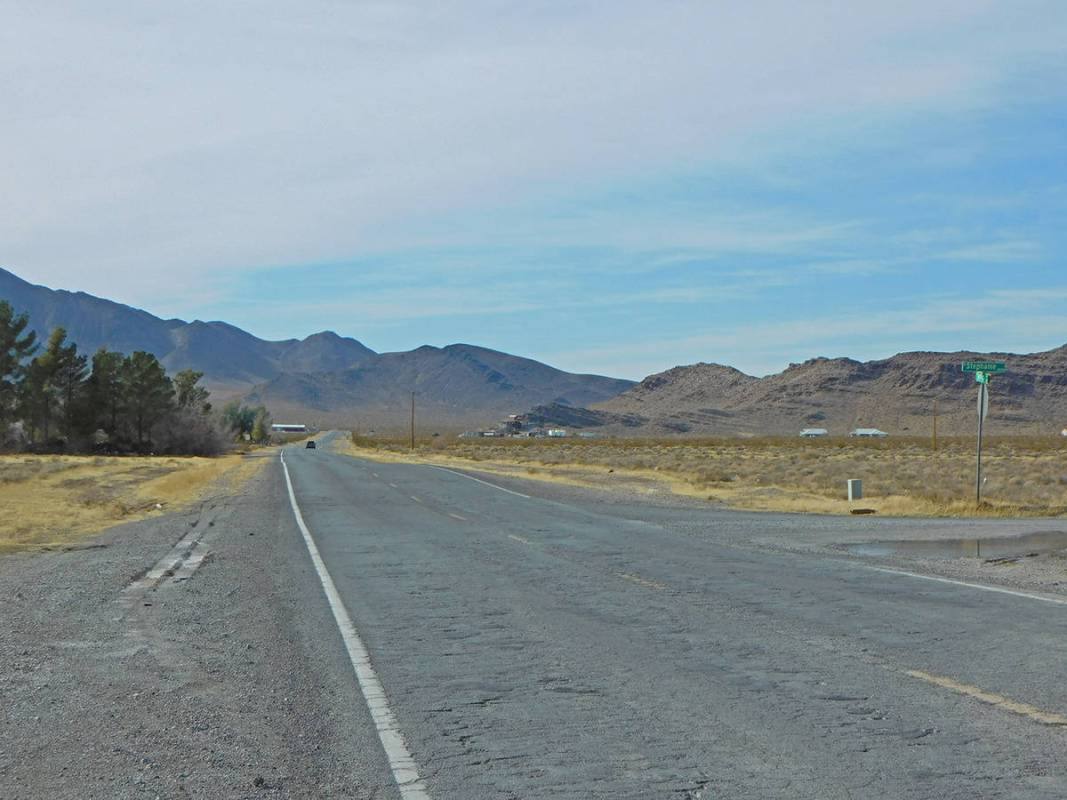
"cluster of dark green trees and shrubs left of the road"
0,300,270,454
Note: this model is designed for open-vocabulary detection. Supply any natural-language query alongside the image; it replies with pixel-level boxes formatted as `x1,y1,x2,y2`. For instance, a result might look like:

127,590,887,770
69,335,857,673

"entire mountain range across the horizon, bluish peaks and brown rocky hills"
0,269,1067,436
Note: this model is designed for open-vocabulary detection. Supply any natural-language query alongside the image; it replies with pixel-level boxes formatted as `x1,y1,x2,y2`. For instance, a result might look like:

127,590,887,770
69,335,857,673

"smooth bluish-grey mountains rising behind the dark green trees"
0,269,633,427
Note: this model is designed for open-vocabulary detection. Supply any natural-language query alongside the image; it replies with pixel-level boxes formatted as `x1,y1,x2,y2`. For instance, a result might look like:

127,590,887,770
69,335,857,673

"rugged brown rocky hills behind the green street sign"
532,346,1067,436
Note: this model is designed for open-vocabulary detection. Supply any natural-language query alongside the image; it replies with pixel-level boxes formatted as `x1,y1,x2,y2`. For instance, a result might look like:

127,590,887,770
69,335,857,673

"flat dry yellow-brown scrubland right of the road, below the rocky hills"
341,437,1067,516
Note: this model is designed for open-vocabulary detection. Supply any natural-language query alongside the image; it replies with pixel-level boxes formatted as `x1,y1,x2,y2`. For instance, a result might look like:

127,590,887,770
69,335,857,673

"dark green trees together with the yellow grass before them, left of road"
0,300,270,554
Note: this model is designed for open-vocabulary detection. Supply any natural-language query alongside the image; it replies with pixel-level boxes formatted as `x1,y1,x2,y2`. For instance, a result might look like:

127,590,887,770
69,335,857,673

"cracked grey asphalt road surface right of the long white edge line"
280,441,1067,800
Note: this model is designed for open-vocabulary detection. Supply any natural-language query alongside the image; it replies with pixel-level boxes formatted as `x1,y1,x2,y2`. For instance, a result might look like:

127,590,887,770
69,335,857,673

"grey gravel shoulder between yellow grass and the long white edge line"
0,457,397,800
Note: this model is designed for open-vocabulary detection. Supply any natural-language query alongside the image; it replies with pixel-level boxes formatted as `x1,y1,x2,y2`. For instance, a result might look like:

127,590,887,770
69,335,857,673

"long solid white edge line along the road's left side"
281,452,430,800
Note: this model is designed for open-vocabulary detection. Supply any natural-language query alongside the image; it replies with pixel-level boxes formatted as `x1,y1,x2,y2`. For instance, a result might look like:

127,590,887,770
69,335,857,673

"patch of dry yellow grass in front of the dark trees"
0,455,266,553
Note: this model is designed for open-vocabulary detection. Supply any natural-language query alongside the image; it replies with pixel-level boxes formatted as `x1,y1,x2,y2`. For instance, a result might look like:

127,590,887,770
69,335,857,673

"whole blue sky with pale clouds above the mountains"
0,0,1067,379
